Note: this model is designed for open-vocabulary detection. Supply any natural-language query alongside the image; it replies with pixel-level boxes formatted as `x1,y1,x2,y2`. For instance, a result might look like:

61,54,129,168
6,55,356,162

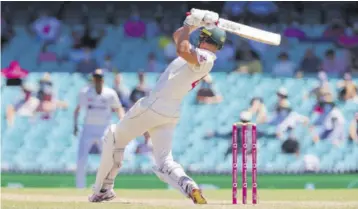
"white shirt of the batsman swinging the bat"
146,48,216,116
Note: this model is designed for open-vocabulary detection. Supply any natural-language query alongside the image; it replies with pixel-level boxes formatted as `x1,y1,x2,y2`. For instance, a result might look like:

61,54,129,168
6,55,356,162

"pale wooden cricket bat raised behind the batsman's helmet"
186,12,281,46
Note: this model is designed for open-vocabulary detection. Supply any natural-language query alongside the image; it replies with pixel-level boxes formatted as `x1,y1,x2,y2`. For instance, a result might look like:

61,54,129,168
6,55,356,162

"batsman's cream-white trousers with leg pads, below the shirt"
94,99,199,193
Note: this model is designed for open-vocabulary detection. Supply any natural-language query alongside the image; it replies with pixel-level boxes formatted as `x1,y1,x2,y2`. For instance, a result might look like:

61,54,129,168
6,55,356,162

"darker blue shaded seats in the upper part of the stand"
1,22,346,72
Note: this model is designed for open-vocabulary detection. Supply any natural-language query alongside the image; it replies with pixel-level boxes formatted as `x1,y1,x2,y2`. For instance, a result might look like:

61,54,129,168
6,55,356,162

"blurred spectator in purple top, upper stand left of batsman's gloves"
124,11,146,38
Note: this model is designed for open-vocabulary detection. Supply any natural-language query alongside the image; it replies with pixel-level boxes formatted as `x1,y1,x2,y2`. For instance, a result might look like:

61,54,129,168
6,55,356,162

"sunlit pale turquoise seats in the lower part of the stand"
1,73,358,172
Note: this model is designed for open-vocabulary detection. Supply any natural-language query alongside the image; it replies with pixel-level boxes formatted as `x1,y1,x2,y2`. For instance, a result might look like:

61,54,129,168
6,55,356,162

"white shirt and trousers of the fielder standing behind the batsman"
76,86,121,188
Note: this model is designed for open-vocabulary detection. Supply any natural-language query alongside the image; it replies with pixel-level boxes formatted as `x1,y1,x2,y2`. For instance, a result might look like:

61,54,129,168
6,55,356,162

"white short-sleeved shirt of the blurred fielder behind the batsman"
78,86,122,125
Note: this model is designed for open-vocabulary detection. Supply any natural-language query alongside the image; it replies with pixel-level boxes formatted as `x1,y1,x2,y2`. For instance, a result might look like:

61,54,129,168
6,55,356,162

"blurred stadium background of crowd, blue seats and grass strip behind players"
1,1,358,188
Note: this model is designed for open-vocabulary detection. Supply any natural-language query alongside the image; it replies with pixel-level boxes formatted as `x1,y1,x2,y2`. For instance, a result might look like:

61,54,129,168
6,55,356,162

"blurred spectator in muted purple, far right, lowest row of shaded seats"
322,49,348,75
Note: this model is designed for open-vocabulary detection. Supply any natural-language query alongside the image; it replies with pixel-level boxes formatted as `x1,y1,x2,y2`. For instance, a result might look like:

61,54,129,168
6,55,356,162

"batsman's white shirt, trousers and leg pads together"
94,48,216,194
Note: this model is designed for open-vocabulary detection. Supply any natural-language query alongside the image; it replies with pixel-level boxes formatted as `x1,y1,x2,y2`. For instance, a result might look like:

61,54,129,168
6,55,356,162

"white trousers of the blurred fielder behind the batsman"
76,125,107,188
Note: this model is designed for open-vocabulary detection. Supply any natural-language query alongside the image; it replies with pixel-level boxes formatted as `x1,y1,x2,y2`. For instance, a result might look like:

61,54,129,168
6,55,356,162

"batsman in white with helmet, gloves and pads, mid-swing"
89,9,226,204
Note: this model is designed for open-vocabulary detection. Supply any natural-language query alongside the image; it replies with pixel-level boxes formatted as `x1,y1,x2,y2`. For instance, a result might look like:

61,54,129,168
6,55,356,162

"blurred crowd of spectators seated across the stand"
1,2,358,167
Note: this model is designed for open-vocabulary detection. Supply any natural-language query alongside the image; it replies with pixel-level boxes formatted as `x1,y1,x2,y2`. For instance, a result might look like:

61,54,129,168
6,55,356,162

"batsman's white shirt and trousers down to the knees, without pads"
115,48,216,150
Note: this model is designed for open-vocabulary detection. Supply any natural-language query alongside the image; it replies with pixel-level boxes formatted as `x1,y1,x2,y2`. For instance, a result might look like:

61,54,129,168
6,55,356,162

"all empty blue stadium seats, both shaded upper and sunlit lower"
1,2,358,173
